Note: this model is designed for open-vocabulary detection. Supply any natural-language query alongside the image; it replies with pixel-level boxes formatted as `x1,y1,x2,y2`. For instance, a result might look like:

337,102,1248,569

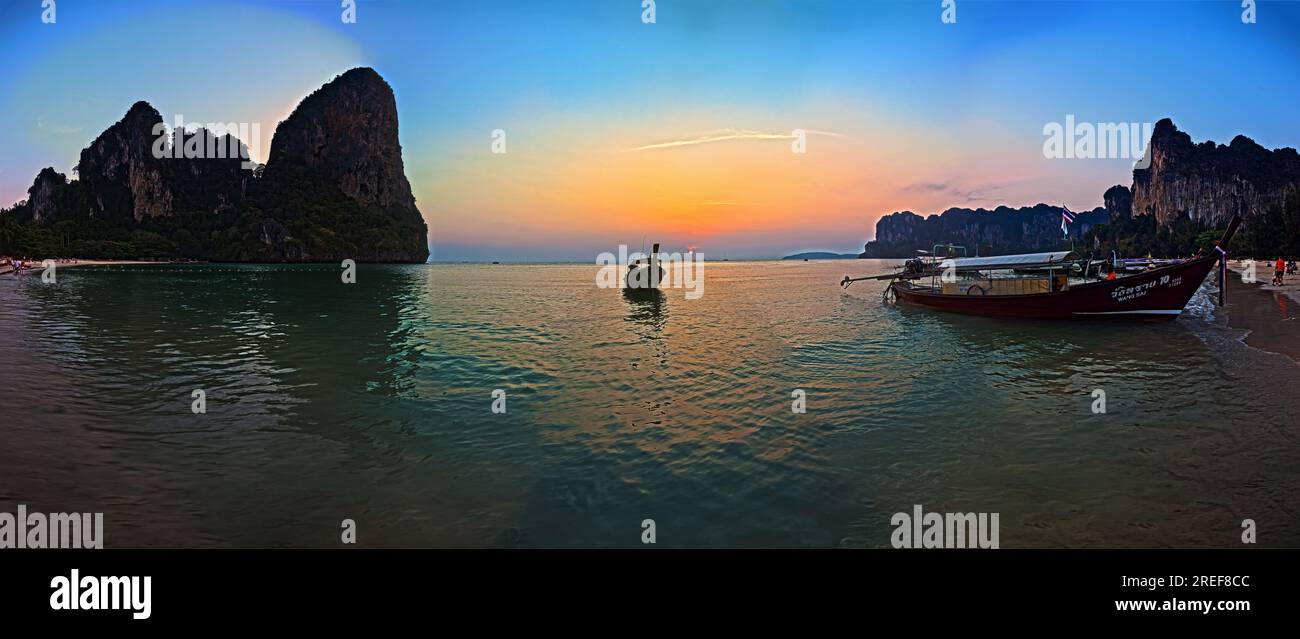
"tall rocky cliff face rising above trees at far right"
1132,118,1300,227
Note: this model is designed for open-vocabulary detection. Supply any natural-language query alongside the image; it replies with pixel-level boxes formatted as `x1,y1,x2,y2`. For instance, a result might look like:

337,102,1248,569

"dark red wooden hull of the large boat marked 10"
891,256,1218,321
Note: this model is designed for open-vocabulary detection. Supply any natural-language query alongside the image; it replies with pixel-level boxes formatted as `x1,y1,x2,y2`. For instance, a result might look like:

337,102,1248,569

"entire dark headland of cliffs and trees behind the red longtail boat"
858,118,1300,258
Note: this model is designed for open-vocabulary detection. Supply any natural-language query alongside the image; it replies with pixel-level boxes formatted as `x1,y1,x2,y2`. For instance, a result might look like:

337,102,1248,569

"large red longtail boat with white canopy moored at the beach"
840,217,1242,320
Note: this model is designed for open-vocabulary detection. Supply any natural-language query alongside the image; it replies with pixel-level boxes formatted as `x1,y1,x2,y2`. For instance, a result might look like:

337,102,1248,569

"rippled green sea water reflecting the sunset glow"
0,261,1300,547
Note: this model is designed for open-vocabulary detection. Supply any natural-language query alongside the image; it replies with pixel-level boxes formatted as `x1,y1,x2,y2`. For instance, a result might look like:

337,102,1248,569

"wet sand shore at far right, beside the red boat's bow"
1227,262,1300,362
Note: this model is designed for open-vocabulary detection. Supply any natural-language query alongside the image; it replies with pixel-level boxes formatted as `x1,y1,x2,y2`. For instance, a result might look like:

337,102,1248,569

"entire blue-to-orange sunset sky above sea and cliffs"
0,0,1300,261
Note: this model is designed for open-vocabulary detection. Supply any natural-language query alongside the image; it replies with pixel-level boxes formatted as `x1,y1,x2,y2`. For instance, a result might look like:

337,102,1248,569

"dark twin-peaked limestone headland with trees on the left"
0,68,429,262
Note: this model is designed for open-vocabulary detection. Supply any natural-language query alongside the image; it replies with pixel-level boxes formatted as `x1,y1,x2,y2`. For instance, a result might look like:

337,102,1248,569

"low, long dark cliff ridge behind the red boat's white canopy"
859,204,1109,257
